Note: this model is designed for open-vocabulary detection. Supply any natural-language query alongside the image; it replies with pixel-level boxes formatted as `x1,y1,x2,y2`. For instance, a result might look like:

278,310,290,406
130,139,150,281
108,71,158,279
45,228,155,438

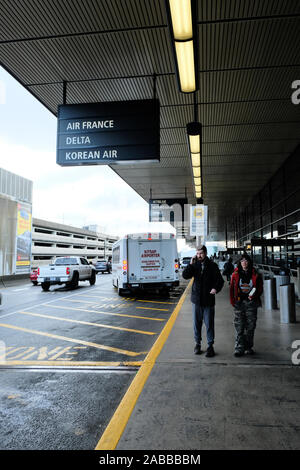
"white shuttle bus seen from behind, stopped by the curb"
112,233,179,295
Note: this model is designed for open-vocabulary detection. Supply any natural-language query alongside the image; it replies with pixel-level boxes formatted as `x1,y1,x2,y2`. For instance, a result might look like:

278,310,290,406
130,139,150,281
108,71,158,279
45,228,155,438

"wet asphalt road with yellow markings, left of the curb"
0,274,183,450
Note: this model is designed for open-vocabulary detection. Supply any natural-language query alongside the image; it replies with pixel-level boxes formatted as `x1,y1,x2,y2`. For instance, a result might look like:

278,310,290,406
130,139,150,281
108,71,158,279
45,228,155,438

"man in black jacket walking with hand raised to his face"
182,245,224,357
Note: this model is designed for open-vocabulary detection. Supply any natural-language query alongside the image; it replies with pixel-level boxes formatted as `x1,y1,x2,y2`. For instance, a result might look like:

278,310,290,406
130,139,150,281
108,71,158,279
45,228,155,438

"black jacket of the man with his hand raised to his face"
182,257,224,307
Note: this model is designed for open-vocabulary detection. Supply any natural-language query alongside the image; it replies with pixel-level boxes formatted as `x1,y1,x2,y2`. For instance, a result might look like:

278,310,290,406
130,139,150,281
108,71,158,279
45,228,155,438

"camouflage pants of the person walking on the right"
234,300,257,352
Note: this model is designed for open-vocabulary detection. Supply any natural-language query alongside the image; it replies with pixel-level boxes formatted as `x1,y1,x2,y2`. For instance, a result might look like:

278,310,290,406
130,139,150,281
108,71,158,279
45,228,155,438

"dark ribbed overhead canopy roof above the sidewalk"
0,0,300,239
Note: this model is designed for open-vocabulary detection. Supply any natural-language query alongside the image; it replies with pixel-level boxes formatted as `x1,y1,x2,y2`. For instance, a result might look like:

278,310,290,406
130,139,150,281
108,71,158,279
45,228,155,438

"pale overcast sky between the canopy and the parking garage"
0,67,192,253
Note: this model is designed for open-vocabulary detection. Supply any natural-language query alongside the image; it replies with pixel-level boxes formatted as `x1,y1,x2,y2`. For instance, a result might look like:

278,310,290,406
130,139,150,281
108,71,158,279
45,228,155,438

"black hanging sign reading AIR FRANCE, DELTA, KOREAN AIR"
56,100,160,166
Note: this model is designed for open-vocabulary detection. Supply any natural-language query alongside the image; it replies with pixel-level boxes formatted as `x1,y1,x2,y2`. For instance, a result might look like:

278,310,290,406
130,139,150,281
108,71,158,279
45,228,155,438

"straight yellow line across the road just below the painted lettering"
1,360,143,367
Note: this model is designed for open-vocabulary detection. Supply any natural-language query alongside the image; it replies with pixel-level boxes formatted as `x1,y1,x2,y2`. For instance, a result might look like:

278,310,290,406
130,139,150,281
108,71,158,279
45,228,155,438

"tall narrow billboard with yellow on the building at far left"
16,202,31,274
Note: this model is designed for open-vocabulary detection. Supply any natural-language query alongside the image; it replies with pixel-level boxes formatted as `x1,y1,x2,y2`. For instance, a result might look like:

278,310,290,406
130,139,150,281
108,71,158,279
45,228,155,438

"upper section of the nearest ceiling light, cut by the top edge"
169,0,193,41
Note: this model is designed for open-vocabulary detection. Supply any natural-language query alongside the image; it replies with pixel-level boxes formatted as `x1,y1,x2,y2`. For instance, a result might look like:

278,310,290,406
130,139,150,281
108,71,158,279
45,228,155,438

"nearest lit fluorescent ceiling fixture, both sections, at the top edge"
165,0,198,93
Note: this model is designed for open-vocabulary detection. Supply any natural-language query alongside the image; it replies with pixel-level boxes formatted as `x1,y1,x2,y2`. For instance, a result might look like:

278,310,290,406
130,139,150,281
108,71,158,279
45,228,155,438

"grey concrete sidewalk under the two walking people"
116,283,300,450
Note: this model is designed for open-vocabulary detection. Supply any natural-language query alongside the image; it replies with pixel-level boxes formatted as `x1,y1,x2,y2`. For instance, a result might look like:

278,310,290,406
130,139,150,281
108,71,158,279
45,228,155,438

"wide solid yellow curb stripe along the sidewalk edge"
95,281,192,450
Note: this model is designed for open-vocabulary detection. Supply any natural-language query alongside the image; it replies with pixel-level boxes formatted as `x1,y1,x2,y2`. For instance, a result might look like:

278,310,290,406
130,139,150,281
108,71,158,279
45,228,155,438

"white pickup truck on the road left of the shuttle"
38,256,96,291
